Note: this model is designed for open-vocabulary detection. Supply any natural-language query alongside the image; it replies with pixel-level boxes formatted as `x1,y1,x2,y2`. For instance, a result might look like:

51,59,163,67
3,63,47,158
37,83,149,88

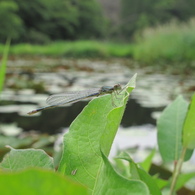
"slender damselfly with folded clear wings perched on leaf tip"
28,84,122,115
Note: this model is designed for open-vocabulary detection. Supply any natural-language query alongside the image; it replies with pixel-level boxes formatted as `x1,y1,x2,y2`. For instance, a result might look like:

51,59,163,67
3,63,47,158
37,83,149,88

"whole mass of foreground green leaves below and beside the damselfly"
0,75,195,195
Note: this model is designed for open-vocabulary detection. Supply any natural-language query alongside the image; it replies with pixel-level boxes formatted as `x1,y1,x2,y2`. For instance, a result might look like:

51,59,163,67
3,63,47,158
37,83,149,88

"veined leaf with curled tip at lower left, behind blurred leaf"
0,148,54,171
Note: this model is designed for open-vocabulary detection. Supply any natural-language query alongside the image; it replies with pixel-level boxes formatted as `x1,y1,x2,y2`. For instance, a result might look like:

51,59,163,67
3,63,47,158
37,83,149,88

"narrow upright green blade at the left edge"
0,39,10,93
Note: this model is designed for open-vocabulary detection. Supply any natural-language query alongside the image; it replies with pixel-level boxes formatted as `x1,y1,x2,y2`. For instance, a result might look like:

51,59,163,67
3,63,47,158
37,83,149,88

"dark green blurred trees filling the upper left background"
0,0,105,44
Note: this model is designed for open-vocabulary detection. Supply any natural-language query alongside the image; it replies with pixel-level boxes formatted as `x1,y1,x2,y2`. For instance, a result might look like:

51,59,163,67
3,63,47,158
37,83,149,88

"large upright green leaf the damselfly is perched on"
59,75,136,191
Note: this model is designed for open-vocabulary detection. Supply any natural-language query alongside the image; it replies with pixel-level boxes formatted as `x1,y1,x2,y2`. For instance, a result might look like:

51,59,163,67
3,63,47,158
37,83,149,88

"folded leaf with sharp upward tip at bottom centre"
93,154,149,195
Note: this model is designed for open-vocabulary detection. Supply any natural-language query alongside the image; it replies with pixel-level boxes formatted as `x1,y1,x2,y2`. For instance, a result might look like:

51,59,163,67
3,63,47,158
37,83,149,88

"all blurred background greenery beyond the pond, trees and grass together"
0,0,195,67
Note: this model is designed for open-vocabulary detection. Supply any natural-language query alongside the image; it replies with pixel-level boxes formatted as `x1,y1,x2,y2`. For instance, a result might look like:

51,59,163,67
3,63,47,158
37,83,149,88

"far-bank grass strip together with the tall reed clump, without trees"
0,18,195,64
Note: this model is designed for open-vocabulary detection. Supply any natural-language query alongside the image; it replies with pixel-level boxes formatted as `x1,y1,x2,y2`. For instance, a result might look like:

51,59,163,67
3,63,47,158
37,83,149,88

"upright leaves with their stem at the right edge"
157,95,195,194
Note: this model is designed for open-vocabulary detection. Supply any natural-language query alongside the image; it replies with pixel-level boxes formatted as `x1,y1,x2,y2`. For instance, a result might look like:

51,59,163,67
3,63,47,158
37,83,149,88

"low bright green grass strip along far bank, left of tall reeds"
0,41,133,58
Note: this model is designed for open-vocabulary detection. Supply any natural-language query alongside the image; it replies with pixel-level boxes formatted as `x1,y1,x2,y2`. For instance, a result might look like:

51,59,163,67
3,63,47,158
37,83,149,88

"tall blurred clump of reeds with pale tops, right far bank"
133,18,195,63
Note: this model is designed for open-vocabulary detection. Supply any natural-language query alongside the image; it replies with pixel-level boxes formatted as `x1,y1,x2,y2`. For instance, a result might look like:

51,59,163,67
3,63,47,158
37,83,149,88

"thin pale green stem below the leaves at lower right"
169,147,187,195
